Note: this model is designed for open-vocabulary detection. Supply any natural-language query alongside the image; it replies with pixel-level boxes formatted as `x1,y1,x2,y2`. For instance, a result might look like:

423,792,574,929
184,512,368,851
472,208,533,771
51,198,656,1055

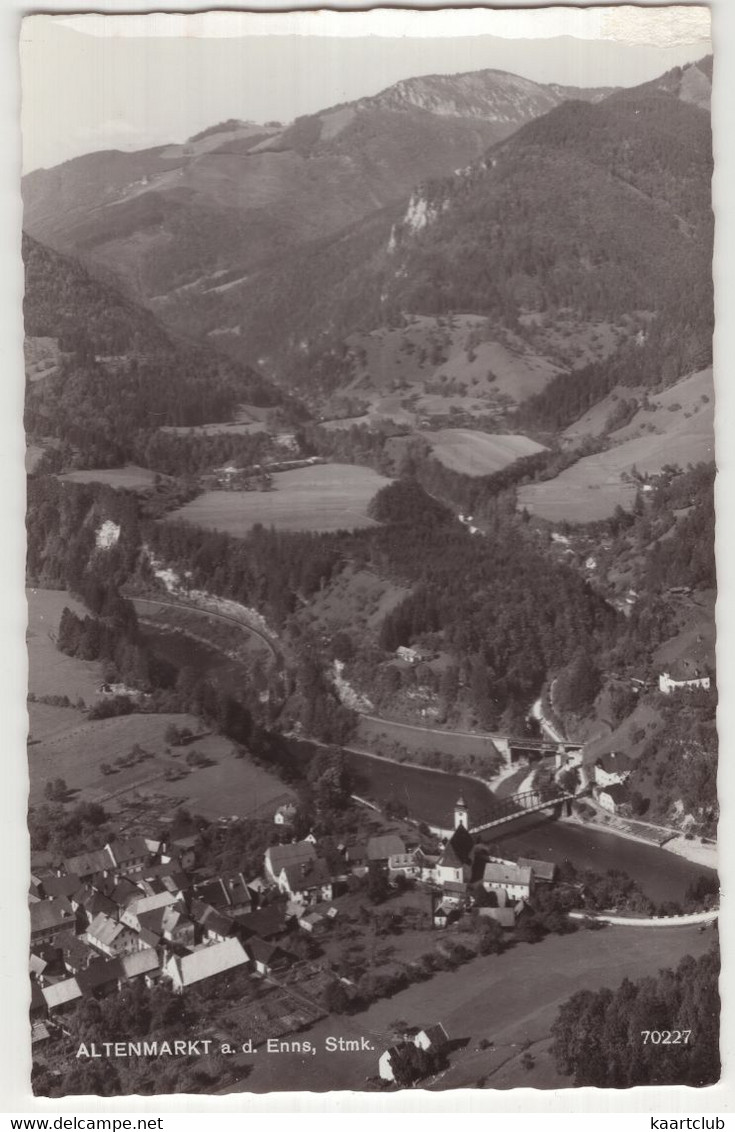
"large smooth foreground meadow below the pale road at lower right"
226,928,712,1092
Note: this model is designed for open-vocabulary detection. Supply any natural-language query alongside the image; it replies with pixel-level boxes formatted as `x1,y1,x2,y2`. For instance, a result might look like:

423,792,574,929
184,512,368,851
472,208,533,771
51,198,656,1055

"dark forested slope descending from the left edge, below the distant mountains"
23,235,281,466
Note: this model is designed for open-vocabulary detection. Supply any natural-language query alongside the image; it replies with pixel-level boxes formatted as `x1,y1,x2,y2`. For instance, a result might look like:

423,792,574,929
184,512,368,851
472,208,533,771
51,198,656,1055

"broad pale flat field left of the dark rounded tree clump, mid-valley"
169,464,390,535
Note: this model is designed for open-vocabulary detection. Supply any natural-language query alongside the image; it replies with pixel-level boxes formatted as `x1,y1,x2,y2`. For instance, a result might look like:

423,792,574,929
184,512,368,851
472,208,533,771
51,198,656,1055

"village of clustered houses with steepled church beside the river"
29,778,584,1087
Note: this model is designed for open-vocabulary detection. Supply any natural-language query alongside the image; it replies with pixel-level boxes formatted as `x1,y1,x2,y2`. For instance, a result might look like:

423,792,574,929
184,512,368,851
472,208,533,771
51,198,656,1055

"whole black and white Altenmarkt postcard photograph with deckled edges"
14,6,720,1103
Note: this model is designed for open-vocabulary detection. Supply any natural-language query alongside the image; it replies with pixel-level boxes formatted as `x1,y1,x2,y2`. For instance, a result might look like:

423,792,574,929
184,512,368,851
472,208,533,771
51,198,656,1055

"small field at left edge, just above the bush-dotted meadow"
26,590,102,703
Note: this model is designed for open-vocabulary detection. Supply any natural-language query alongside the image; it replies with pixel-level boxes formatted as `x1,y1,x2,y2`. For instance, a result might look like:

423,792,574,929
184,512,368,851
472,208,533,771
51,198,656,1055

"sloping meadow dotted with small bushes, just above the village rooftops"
28,704,289,818
